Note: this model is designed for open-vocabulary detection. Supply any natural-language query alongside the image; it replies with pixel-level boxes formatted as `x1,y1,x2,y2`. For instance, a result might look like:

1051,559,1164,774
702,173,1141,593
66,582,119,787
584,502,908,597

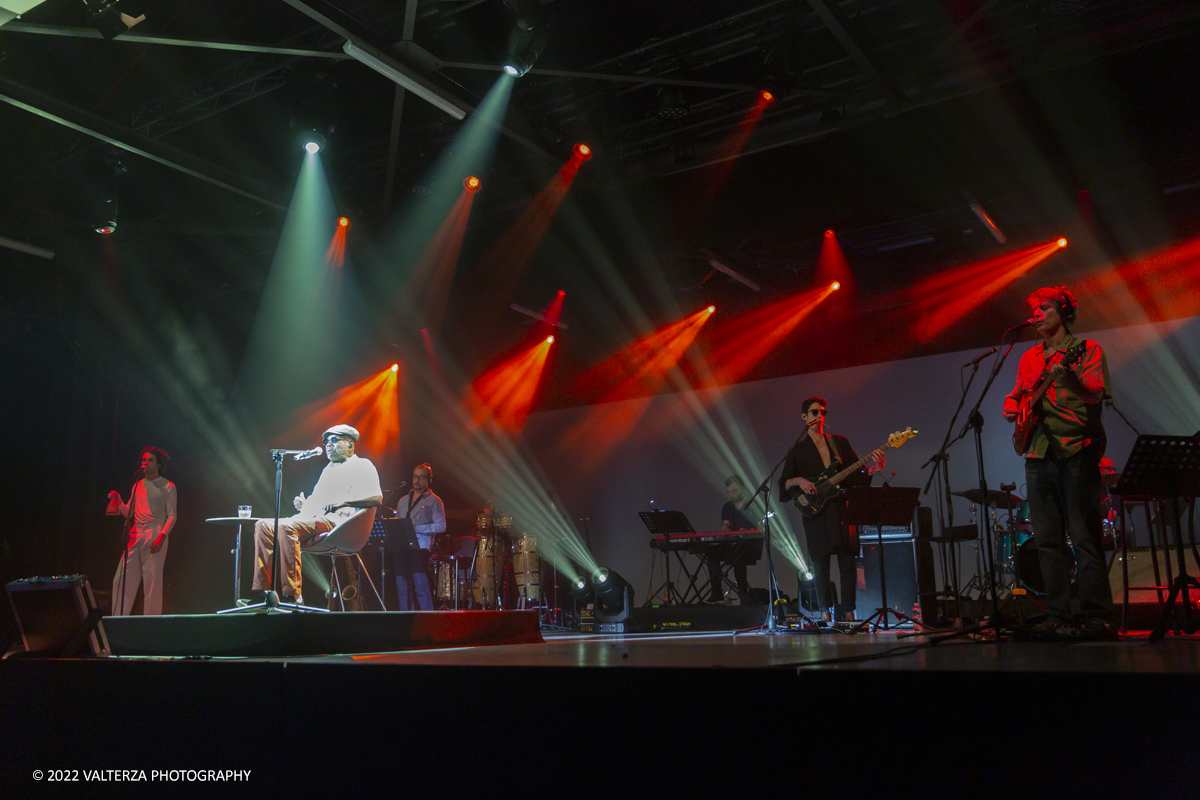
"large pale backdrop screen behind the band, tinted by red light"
526,318,1200,610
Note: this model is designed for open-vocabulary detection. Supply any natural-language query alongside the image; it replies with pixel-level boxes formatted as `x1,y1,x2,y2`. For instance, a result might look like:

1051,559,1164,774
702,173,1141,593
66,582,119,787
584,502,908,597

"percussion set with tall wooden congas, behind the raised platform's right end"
430,513,542,610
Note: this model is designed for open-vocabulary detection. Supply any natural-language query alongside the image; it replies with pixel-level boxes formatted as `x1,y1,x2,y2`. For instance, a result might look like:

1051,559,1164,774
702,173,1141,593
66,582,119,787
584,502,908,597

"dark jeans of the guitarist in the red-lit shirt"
1025,447,1114,621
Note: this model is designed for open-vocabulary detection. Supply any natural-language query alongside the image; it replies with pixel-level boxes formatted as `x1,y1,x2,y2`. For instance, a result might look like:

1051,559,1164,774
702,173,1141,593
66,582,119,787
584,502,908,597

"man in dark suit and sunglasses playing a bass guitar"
779,397,884,621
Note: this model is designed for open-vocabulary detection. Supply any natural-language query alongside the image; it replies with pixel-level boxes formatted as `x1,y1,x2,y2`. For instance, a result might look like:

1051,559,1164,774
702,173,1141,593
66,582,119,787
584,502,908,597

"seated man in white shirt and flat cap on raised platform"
251,425,383,603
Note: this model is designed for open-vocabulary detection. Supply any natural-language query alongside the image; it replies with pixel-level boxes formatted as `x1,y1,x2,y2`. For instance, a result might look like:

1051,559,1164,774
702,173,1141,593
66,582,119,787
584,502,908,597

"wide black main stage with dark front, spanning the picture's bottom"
0,613,1200,799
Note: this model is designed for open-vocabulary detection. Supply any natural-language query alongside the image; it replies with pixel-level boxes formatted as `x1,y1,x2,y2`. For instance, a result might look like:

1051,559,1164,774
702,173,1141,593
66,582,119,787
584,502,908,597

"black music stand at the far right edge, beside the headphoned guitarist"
1112,434,1200,642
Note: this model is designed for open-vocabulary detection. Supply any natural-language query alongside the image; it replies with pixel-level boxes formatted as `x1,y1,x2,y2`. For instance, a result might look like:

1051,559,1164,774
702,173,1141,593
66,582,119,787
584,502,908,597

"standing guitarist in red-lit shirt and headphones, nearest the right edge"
1003,287,1117,639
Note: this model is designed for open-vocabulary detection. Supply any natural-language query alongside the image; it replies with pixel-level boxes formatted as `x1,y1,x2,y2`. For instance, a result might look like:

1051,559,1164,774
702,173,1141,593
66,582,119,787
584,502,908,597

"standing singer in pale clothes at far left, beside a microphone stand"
104,447,176,616
